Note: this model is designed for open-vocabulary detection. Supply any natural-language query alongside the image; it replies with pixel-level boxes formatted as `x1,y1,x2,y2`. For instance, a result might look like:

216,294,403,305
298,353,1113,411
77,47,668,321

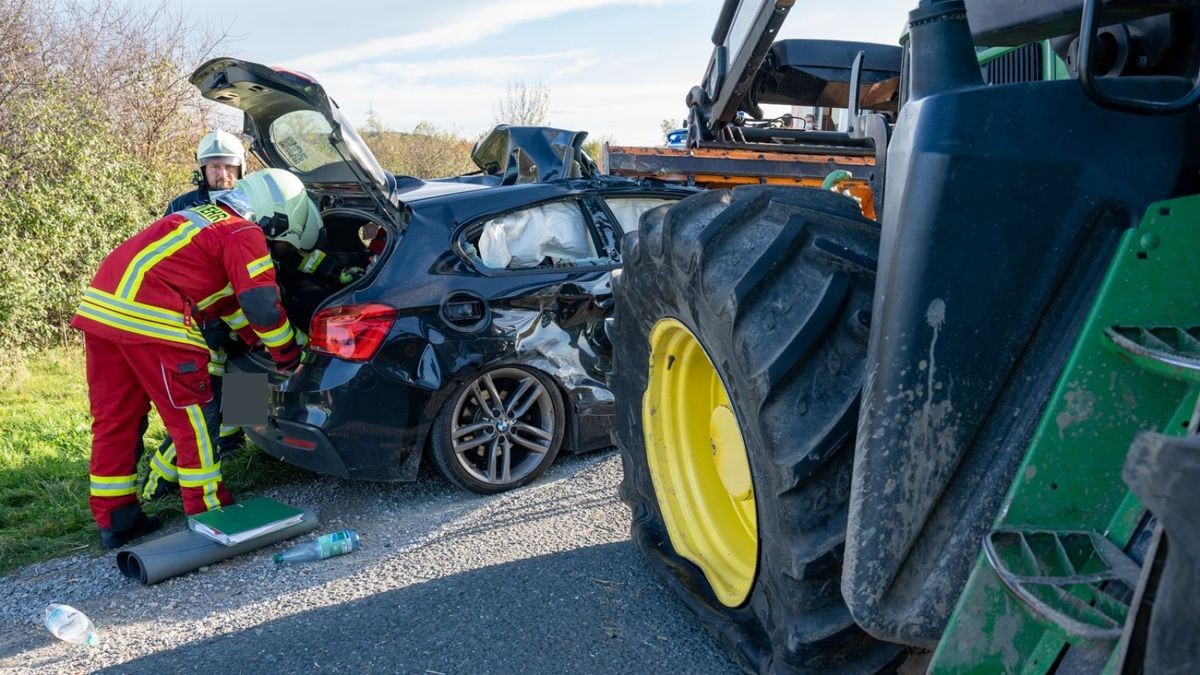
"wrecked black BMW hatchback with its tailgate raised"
191,58,694,492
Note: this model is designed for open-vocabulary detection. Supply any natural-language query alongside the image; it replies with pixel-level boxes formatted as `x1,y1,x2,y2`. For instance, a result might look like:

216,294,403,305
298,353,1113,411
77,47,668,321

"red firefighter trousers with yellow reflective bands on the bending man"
84,334,233,530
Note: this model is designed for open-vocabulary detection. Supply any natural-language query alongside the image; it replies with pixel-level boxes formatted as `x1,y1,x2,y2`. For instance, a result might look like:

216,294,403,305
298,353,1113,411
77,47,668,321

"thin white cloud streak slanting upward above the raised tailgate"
289,0,680,71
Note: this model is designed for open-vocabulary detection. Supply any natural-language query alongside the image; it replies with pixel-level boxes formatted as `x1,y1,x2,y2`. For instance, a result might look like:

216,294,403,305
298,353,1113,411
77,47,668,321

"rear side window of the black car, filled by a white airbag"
467,201,600,269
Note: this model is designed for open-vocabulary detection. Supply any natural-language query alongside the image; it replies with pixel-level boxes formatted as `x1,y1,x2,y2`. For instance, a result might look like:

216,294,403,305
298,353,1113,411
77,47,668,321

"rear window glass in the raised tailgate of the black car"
270,108,386,186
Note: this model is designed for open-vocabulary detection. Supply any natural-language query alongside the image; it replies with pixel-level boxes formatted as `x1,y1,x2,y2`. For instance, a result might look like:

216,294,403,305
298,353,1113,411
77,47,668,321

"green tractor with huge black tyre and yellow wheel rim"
612,0,1200,673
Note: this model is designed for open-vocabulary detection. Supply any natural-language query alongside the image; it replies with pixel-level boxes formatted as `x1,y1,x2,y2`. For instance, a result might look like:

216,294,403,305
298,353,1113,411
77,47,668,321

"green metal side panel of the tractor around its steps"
930,196,1200,674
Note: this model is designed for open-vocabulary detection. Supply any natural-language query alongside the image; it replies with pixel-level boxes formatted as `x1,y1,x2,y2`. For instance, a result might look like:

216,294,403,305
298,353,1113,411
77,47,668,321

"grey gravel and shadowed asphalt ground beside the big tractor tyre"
0,452,738,675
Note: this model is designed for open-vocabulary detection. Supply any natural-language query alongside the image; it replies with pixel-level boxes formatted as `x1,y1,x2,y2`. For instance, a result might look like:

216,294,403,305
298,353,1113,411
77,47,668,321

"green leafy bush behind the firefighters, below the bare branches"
0,86,178,370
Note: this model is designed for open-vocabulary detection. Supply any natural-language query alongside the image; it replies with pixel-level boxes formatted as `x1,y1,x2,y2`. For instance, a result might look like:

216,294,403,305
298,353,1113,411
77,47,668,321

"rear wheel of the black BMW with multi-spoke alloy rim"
430,365,566,495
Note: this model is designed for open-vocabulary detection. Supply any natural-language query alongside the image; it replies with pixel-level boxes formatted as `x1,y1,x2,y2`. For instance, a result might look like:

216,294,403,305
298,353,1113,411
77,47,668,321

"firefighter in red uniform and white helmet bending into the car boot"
71,169,322,549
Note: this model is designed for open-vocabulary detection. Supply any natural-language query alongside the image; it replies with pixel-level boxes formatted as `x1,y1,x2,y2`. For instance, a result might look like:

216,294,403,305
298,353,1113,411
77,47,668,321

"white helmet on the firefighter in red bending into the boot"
229,169,324,252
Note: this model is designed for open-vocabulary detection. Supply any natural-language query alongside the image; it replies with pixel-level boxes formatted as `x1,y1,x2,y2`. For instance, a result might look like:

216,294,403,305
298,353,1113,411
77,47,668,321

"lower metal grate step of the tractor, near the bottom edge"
983,530,1141,647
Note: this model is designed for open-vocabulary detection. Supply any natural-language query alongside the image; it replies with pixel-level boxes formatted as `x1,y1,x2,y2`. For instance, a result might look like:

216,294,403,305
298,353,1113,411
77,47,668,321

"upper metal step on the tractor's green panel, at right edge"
1104,325,1200,384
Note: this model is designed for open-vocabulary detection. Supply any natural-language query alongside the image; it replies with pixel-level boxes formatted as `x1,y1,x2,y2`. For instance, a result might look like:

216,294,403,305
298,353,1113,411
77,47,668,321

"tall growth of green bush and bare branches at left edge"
0,0,229,377
